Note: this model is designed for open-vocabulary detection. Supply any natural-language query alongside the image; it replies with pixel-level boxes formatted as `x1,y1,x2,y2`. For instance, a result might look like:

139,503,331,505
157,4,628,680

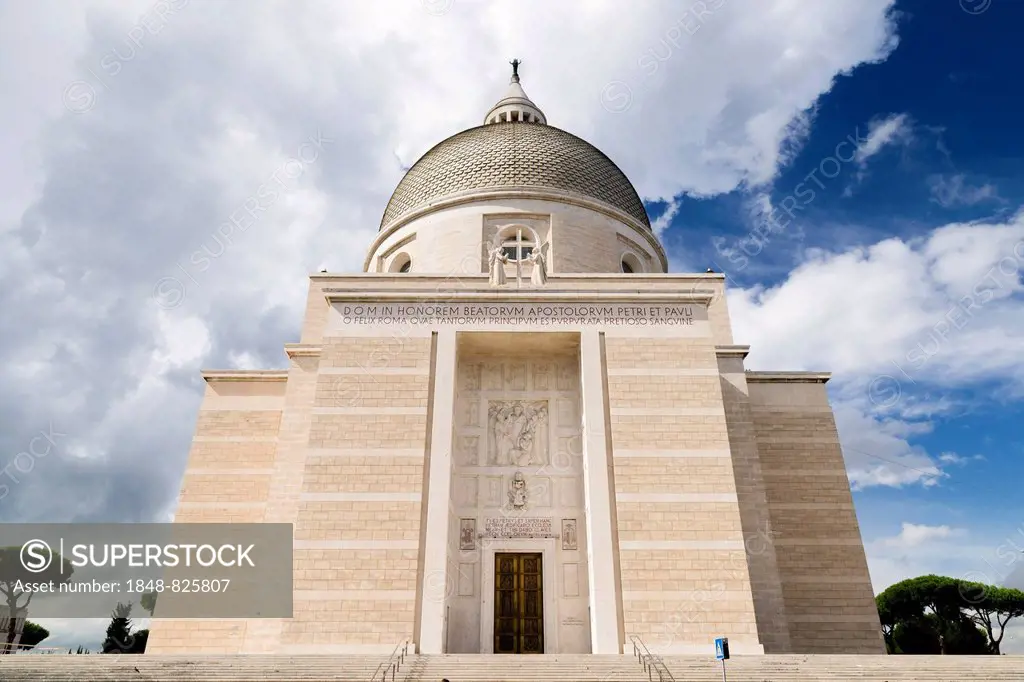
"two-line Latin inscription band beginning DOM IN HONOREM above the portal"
338,303,696,327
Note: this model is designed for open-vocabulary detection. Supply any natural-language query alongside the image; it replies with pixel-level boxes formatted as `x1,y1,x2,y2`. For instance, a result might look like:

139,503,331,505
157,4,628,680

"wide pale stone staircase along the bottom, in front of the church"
0,654,1024,682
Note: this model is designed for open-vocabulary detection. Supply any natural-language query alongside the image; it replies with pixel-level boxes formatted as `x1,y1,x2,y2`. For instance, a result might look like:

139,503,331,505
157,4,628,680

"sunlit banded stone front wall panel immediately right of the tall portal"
605,334,762,653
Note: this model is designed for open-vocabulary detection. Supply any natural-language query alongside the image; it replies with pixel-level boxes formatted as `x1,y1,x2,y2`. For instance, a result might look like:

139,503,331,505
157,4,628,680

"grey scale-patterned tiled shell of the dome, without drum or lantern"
381,121,650,229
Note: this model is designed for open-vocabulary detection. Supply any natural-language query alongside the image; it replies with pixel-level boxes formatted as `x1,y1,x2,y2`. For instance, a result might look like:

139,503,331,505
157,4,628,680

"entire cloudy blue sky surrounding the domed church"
0,0,1024,650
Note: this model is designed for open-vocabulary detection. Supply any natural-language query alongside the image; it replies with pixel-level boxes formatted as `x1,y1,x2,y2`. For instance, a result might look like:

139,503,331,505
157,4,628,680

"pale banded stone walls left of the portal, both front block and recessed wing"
150,329,431,654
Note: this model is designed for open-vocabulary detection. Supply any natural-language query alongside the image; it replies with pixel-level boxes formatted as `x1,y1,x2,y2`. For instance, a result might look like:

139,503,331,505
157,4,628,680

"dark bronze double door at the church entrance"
495,553,544,653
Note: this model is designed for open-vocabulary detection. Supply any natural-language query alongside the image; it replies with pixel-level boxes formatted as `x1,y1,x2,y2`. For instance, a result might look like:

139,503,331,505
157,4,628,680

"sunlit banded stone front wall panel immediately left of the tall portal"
278,335,431,653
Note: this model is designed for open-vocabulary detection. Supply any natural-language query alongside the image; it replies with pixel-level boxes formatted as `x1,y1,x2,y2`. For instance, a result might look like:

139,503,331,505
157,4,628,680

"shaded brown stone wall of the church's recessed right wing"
748,372,885,653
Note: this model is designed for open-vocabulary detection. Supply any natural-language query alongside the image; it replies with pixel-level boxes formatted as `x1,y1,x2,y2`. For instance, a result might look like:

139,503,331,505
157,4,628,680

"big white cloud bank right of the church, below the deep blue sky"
729,213,1024,382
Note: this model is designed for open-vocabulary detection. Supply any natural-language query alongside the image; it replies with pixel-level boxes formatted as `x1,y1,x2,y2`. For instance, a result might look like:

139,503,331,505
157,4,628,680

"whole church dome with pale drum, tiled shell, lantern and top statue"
362,59,669,274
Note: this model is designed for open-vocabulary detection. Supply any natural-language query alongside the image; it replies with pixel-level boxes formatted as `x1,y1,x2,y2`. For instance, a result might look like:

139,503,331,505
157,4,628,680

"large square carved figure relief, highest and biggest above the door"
487,400,548,467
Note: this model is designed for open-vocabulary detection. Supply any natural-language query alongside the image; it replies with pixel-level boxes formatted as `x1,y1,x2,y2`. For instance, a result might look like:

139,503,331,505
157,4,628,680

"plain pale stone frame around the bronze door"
480,538,558,655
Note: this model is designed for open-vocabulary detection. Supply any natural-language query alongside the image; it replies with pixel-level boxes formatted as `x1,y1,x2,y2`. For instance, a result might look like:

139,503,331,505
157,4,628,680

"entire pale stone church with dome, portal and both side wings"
148,63,885,655
